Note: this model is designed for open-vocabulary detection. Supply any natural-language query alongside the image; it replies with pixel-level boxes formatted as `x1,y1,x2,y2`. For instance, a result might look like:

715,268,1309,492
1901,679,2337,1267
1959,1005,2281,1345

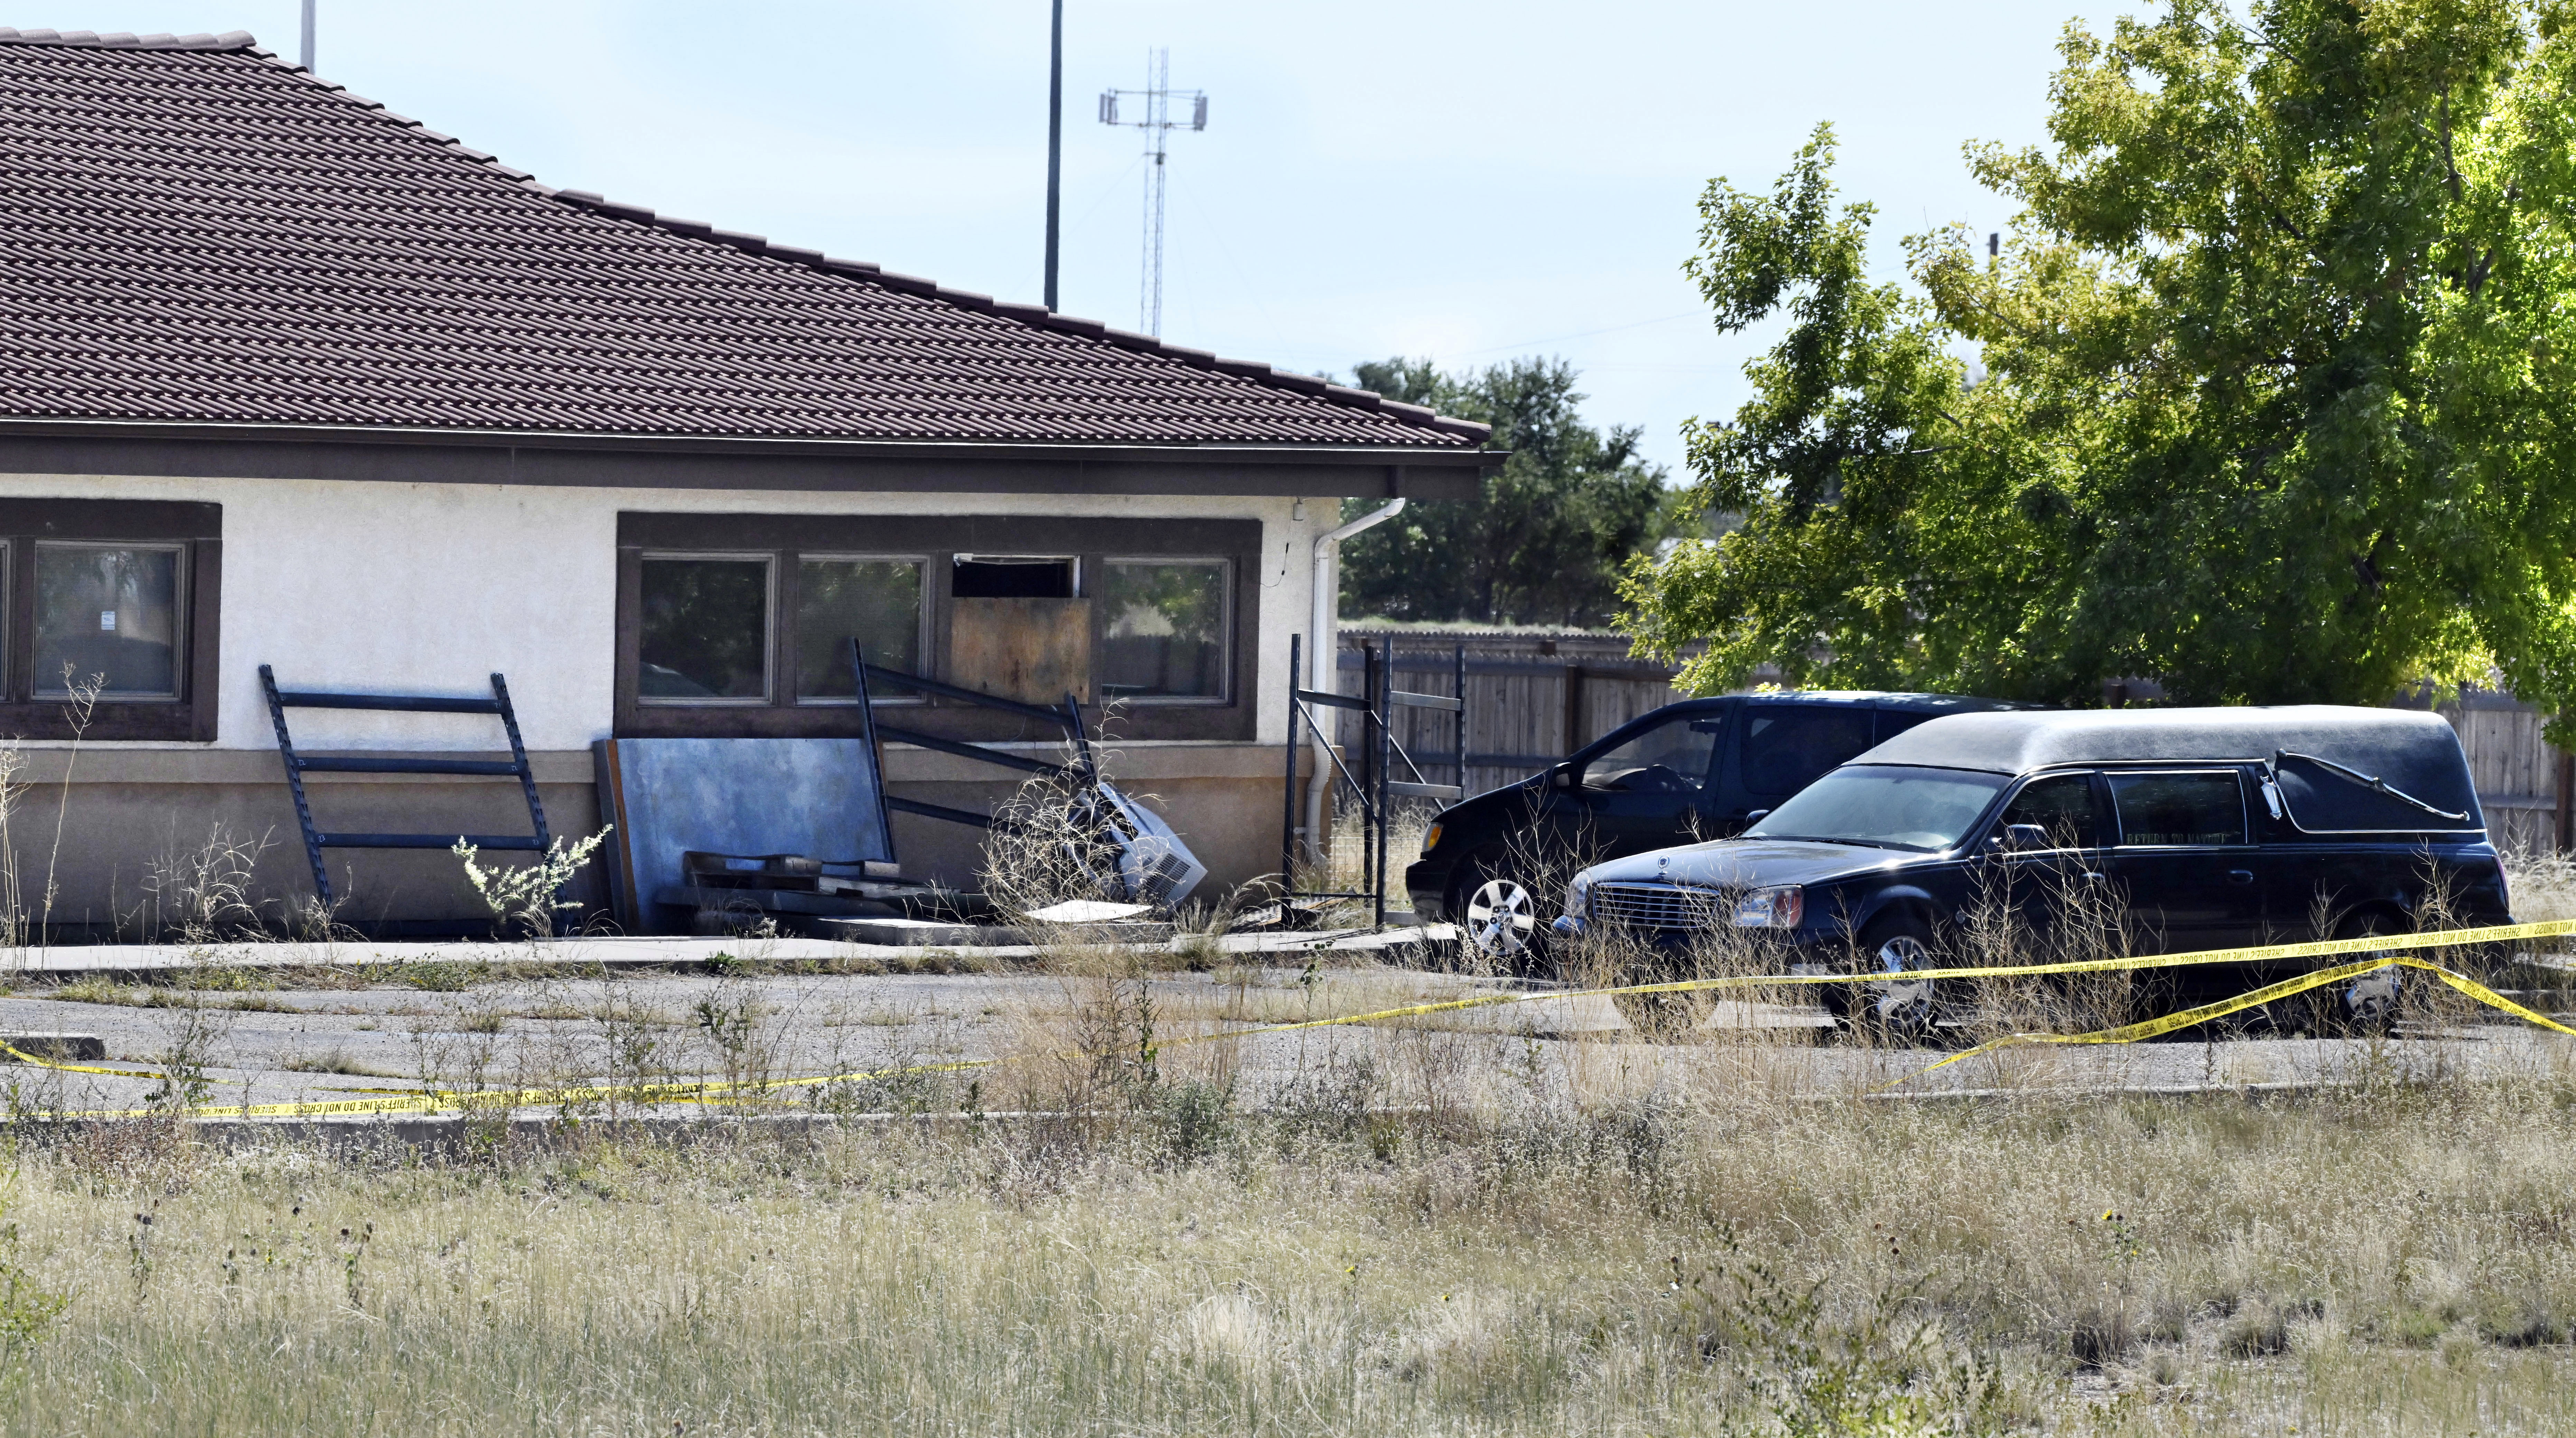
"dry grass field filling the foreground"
0,1067,2576,1433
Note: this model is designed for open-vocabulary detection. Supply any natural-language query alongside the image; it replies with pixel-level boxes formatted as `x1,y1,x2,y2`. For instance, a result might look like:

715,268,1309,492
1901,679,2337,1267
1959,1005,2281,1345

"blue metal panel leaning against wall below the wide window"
598,740,894,930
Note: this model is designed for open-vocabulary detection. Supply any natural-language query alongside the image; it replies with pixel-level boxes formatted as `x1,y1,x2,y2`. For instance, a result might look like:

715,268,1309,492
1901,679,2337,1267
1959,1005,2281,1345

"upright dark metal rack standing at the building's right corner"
1280,634,1466,928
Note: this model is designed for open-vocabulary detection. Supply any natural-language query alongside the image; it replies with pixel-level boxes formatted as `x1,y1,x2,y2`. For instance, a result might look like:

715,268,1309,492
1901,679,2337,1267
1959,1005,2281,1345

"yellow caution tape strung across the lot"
0,920,2576,1119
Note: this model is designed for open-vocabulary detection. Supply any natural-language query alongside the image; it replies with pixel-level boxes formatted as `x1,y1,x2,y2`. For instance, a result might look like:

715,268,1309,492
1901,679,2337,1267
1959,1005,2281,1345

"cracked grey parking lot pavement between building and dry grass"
0,956,2576,1129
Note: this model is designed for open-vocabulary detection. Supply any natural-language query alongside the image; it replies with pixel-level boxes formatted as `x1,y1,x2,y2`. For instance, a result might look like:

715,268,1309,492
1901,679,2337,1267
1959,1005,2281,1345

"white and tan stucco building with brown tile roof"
0,31,1499,943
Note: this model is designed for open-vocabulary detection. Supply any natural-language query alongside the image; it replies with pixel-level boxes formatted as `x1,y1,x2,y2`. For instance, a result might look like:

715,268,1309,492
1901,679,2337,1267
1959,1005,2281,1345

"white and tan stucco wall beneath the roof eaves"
0,474,1340,917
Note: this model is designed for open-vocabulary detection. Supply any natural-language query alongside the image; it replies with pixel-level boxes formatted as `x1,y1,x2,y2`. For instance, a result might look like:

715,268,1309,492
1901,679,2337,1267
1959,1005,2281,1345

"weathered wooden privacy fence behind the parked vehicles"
1334,629,2576,850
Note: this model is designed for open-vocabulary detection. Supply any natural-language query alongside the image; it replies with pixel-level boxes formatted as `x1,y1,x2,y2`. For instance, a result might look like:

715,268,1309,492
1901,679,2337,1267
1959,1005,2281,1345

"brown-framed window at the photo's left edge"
0,500,224,742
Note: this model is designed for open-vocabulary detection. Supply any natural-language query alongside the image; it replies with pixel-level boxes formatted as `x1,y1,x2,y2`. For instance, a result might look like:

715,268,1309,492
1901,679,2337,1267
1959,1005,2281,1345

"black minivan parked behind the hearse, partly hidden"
1404,691,2022,964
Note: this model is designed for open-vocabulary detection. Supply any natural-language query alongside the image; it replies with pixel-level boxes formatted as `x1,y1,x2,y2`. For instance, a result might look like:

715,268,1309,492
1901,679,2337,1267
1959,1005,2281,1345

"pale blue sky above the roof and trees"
30,0,2143,471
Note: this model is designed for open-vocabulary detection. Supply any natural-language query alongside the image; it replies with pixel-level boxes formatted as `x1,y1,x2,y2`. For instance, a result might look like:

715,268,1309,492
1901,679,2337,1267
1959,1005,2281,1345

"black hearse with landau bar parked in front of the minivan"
1558,706,2512,1031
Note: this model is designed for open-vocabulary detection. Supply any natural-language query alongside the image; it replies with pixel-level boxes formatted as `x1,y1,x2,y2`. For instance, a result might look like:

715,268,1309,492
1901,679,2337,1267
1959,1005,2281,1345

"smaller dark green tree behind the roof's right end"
1342,358,1674,626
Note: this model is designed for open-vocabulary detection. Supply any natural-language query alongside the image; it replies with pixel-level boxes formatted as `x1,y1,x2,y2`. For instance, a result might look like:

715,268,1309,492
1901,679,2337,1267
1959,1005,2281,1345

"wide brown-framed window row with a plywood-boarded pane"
610,510,1283,742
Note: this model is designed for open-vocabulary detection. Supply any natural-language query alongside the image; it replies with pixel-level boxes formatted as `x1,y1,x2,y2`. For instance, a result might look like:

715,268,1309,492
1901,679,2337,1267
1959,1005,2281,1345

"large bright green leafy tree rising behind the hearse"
1628,0,2576,742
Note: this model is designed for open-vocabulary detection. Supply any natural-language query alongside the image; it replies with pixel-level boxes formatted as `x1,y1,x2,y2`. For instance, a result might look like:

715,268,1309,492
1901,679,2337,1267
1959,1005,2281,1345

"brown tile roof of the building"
0,28,1486,451
